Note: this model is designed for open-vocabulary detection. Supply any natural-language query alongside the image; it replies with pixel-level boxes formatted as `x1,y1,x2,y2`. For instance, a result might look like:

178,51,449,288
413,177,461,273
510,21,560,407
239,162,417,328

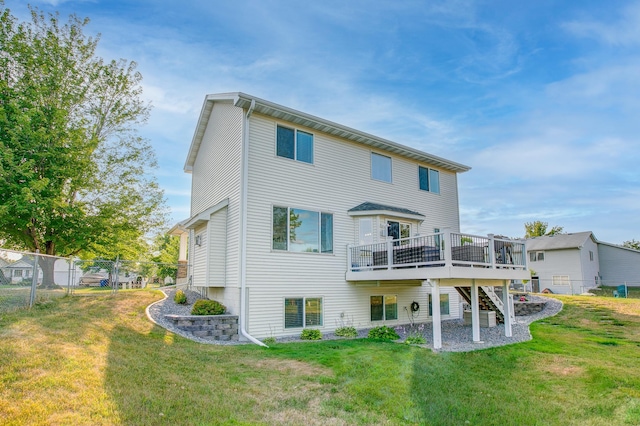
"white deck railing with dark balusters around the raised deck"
347,231,527,272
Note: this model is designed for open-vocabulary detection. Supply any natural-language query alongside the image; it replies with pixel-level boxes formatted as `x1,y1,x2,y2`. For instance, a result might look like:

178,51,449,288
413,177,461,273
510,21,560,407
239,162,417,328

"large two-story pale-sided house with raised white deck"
171,93,529,348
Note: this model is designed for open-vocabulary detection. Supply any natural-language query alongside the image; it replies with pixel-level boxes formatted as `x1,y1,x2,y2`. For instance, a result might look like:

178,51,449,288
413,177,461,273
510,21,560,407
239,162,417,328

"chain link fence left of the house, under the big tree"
0,248,187,313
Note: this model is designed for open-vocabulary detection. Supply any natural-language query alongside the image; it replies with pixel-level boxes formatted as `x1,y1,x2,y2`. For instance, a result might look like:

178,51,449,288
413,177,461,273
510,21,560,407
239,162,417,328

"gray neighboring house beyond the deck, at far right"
527,231,640,294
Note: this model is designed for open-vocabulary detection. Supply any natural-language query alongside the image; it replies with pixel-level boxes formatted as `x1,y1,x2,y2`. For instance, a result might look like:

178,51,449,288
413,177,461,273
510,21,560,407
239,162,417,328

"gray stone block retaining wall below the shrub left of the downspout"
164,315,238,340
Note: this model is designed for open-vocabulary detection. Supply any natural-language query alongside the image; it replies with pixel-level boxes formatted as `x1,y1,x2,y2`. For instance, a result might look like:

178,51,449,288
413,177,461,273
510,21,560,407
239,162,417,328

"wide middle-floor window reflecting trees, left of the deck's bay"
272,206,333,253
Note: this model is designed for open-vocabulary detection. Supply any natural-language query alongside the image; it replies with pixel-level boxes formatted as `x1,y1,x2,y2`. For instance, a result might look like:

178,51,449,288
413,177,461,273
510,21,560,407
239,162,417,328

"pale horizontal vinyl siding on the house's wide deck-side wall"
244,114,459,337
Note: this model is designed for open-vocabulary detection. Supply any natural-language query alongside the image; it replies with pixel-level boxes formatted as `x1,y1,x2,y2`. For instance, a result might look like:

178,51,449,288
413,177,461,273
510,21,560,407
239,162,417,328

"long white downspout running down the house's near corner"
240,99,268,347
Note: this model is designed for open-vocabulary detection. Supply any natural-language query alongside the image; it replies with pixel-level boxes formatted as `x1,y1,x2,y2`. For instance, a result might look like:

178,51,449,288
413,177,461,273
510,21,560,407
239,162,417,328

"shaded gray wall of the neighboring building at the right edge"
598,244,640,286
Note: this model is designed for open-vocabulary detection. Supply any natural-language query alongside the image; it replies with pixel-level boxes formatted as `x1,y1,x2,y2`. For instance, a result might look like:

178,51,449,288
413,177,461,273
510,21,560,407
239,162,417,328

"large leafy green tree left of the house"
0,4,166,285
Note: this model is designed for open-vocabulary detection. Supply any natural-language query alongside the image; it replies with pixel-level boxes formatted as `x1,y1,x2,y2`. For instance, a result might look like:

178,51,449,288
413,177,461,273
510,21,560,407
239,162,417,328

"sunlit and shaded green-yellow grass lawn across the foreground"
0,290,640,425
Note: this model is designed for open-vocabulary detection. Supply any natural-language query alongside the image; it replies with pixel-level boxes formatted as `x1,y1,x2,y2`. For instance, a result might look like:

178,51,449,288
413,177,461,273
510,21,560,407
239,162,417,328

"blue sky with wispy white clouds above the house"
5,0,640,244
